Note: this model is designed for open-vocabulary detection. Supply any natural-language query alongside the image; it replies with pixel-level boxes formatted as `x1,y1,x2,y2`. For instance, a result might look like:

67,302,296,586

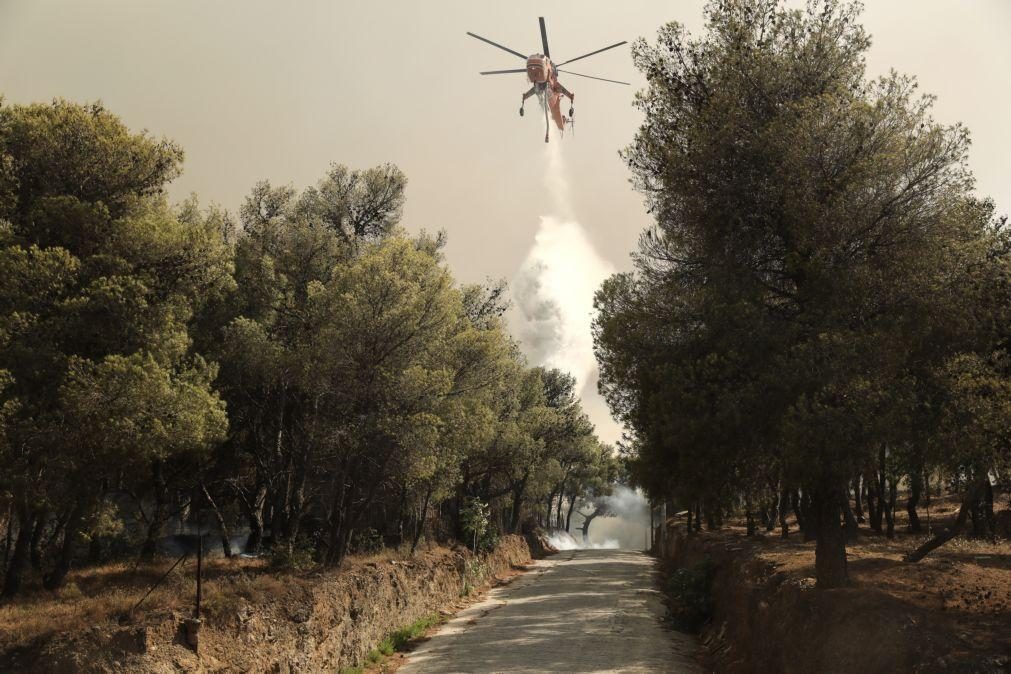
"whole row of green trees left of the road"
0,100,615,597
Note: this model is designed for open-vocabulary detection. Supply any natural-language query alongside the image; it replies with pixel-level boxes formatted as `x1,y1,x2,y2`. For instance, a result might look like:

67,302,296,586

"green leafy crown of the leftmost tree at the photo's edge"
0,100,234,592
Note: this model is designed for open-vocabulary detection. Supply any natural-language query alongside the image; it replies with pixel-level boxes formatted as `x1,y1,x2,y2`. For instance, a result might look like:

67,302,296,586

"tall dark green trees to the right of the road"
594,0,1011,587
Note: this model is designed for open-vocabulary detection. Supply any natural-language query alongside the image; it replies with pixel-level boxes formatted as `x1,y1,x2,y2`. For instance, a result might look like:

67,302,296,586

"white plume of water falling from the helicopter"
513,142,615,404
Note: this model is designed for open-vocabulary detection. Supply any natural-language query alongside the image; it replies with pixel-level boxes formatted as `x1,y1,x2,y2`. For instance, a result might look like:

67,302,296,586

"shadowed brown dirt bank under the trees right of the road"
663,524,1011,674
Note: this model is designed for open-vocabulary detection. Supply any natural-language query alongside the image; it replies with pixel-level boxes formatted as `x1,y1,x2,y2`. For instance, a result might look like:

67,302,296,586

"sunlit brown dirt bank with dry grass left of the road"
4,536,531,674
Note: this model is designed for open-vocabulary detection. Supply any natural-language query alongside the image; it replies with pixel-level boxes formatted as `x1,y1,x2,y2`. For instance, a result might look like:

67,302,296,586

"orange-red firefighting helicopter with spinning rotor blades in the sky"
467,16,629,142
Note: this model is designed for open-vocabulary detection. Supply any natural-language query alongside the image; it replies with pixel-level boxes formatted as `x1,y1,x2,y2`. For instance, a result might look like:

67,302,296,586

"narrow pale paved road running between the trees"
397,550,701,674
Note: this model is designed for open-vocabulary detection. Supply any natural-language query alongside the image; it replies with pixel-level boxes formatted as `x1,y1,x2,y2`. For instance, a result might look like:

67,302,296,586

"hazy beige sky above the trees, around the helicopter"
0,0,1011,448
